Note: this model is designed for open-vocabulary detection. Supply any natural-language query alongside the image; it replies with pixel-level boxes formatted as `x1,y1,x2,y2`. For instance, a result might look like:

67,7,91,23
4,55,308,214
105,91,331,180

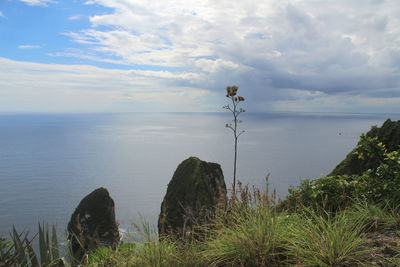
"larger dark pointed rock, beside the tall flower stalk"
158,157,226,236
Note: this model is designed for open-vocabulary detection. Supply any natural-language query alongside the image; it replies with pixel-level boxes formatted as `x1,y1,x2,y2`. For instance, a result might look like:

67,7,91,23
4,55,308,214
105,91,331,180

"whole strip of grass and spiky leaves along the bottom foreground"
0,186,400,267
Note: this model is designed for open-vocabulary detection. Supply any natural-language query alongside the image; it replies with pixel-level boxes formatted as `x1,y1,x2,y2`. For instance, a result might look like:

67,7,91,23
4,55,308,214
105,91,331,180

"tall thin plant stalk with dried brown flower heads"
223,85,245,194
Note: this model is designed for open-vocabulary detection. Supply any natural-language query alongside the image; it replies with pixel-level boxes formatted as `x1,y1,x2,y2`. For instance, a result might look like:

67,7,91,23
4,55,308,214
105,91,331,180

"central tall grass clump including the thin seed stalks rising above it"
199,179,290,266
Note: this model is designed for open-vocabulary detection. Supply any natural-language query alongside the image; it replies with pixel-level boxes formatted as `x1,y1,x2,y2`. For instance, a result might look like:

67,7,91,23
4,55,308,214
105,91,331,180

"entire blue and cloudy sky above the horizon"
0,0,400,113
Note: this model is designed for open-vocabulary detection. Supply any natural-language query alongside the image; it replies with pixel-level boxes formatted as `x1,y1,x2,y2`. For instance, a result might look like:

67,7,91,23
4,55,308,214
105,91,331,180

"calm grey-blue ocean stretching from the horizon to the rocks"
0,113,400,235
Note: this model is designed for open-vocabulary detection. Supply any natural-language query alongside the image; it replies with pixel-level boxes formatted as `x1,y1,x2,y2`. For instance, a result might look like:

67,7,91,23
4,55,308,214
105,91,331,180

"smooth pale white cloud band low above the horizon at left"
0,58,217,112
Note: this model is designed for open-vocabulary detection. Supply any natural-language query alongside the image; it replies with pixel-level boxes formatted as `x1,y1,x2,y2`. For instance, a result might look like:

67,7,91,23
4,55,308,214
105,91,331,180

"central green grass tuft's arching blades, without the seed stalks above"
201,207,288,266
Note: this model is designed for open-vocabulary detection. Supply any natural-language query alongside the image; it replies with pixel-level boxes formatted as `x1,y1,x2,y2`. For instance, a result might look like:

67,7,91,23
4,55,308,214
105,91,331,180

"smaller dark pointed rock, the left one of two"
68,187,120,261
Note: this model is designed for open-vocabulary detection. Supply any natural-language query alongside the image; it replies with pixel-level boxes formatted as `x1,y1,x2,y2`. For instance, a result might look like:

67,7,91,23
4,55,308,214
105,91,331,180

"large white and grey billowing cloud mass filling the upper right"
61,0,400,111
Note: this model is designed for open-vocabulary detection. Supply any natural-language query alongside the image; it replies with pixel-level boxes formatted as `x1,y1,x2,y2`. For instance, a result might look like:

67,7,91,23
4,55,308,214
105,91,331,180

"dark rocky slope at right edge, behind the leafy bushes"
329,119,400,175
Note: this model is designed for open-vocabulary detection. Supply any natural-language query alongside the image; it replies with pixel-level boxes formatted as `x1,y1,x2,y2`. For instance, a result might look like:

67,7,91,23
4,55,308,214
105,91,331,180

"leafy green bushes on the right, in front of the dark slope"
285,135,400,211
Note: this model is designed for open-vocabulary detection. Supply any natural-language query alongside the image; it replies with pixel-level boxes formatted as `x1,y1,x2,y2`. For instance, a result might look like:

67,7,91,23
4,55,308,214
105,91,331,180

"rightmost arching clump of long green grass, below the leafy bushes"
290,210,365,266
